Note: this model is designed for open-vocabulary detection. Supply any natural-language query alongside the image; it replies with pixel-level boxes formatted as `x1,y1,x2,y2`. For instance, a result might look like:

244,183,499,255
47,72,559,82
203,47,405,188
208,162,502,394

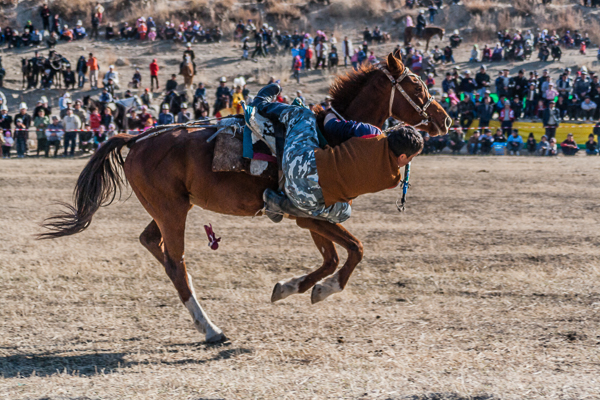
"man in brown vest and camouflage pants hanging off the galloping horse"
250,84,423,223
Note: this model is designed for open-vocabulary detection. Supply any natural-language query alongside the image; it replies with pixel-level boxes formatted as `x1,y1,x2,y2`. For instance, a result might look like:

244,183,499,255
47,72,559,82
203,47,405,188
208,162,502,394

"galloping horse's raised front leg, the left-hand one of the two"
271,232,340,302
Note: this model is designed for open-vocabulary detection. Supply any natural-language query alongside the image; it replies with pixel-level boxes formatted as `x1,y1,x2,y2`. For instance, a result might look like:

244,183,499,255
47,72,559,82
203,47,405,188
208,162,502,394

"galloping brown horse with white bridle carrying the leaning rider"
41,54,452,342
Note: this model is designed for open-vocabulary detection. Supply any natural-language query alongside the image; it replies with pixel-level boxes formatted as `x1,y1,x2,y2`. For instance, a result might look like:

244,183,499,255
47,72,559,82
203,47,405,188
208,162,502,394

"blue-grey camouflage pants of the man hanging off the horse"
279,106,352,223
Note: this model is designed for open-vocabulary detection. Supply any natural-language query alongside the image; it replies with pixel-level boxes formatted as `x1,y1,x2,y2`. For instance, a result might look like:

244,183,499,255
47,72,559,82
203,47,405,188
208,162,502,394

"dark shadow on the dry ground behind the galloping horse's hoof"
0,344,252,378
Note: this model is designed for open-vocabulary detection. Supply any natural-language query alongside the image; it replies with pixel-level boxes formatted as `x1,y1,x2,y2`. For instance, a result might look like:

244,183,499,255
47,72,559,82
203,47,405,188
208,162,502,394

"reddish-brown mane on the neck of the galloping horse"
329,63,377,113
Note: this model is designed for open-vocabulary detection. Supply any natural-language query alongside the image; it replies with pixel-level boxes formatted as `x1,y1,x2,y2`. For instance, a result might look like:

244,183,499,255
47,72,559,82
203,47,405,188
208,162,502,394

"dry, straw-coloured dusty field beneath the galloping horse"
0,157,600,399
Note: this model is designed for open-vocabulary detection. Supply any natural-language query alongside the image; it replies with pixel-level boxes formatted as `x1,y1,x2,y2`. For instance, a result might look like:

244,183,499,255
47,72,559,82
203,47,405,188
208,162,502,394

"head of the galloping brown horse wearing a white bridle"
380,51,452,136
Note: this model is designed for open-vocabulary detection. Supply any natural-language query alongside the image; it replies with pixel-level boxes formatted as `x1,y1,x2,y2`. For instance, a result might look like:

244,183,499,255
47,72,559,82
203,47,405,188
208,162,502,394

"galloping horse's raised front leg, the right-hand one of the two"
296,218,363,304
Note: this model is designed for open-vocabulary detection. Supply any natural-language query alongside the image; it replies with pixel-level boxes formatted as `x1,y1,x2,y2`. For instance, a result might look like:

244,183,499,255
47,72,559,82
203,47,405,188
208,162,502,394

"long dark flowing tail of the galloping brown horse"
37,134,138,239
